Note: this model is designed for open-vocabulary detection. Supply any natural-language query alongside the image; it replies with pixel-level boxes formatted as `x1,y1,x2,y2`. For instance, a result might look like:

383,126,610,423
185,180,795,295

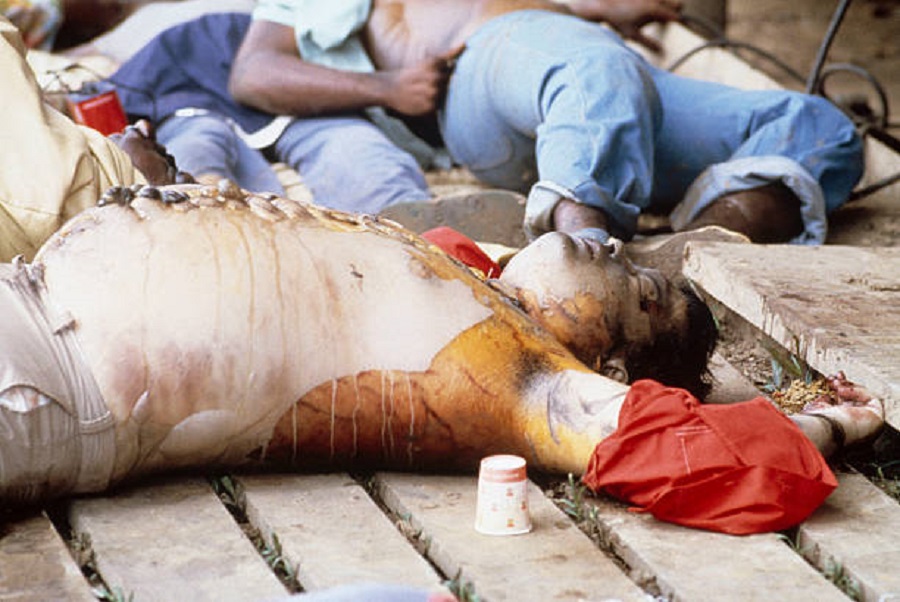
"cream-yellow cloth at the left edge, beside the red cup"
0,16,144,262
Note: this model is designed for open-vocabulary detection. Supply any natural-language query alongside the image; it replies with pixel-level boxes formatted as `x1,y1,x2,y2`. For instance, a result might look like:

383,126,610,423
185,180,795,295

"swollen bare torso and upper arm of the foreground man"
34,186,625,492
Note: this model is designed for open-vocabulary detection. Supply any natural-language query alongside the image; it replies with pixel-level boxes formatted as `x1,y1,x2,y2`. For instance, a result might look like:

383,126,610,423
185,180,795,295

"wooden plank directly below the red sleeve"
592,500,847,602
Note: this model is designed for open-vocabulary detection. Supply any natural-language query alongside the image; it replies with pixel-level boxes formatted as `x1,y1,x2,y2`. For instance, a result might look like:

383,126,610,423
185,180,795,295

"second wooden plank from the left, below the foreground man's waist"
70,479,286,602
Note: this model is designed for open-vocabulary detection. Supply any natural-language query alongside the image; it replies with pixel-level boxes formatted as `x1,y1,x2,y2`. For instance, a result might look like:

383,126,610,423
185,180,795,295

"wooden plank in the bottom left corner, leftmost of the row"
0,514,96,602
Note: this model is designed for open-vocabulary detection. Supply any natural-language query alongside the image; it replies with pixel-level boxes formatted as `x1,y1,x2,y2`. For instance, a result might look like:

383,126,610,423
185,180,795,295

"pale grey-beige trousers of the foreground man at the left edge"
0,263,115,502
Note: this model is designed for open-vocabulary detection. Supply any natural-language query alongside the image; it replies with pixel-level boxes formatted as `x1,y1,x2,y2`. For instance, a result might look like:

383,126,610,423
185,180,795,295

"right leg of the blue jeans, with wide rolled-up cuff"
653,71,863,243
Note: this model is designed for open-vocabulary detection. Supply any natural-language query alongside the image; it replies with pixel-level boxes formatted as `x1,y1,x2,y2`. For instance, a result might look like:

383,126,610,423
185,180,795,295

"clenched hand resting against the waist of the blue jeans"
385,47,463,117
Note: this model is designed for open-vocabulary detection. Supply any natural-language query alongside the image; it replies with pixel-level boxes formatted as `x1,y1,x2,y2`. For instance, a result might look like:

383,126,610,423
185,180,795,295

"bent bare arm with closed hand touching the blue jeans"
229,21,458,117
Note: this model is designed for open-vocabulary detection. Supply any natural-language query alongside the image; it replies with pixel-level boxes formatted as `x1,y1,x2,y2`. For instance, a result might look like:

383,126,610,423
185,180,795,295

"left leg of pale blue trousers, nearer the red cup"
156,115,284,195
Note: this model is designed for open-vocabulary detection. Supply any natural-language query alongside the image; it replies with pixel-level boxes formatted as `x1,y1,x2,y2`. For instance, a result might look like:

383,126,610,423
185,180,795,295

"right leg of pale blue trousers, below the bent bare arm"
274,117,431,214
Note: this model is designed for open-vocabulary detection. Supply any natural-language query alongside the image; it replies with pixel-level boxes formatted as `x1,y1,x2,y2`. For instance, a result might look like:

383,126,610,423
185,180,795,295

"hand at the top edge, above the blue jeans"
570,0,682,52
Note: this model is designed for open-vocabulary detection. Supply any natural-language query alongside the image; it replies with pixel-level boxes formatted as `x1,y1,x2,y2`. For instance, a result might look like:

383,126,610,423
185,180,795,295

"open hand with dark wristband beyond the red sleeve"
792,373,884,457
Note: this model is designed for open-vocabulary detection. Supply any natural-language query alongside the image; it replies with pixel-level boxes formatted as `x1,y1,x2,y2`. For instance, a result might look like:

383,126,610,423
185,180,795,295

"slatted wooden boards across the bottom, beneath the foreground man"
0,464,900,602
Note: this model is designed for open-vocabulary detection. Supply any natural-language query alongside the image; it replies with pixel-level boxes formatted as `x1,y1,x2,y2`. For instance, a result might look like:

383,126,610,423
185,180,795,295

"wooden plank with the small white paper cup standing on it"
376,474,647,602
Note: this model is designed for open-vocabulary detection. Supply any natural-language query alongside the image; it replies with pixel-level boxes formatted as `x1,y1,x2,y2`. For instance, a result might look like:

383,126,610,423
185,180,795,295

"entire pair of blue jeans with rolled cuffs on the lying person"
441,11,862,242
